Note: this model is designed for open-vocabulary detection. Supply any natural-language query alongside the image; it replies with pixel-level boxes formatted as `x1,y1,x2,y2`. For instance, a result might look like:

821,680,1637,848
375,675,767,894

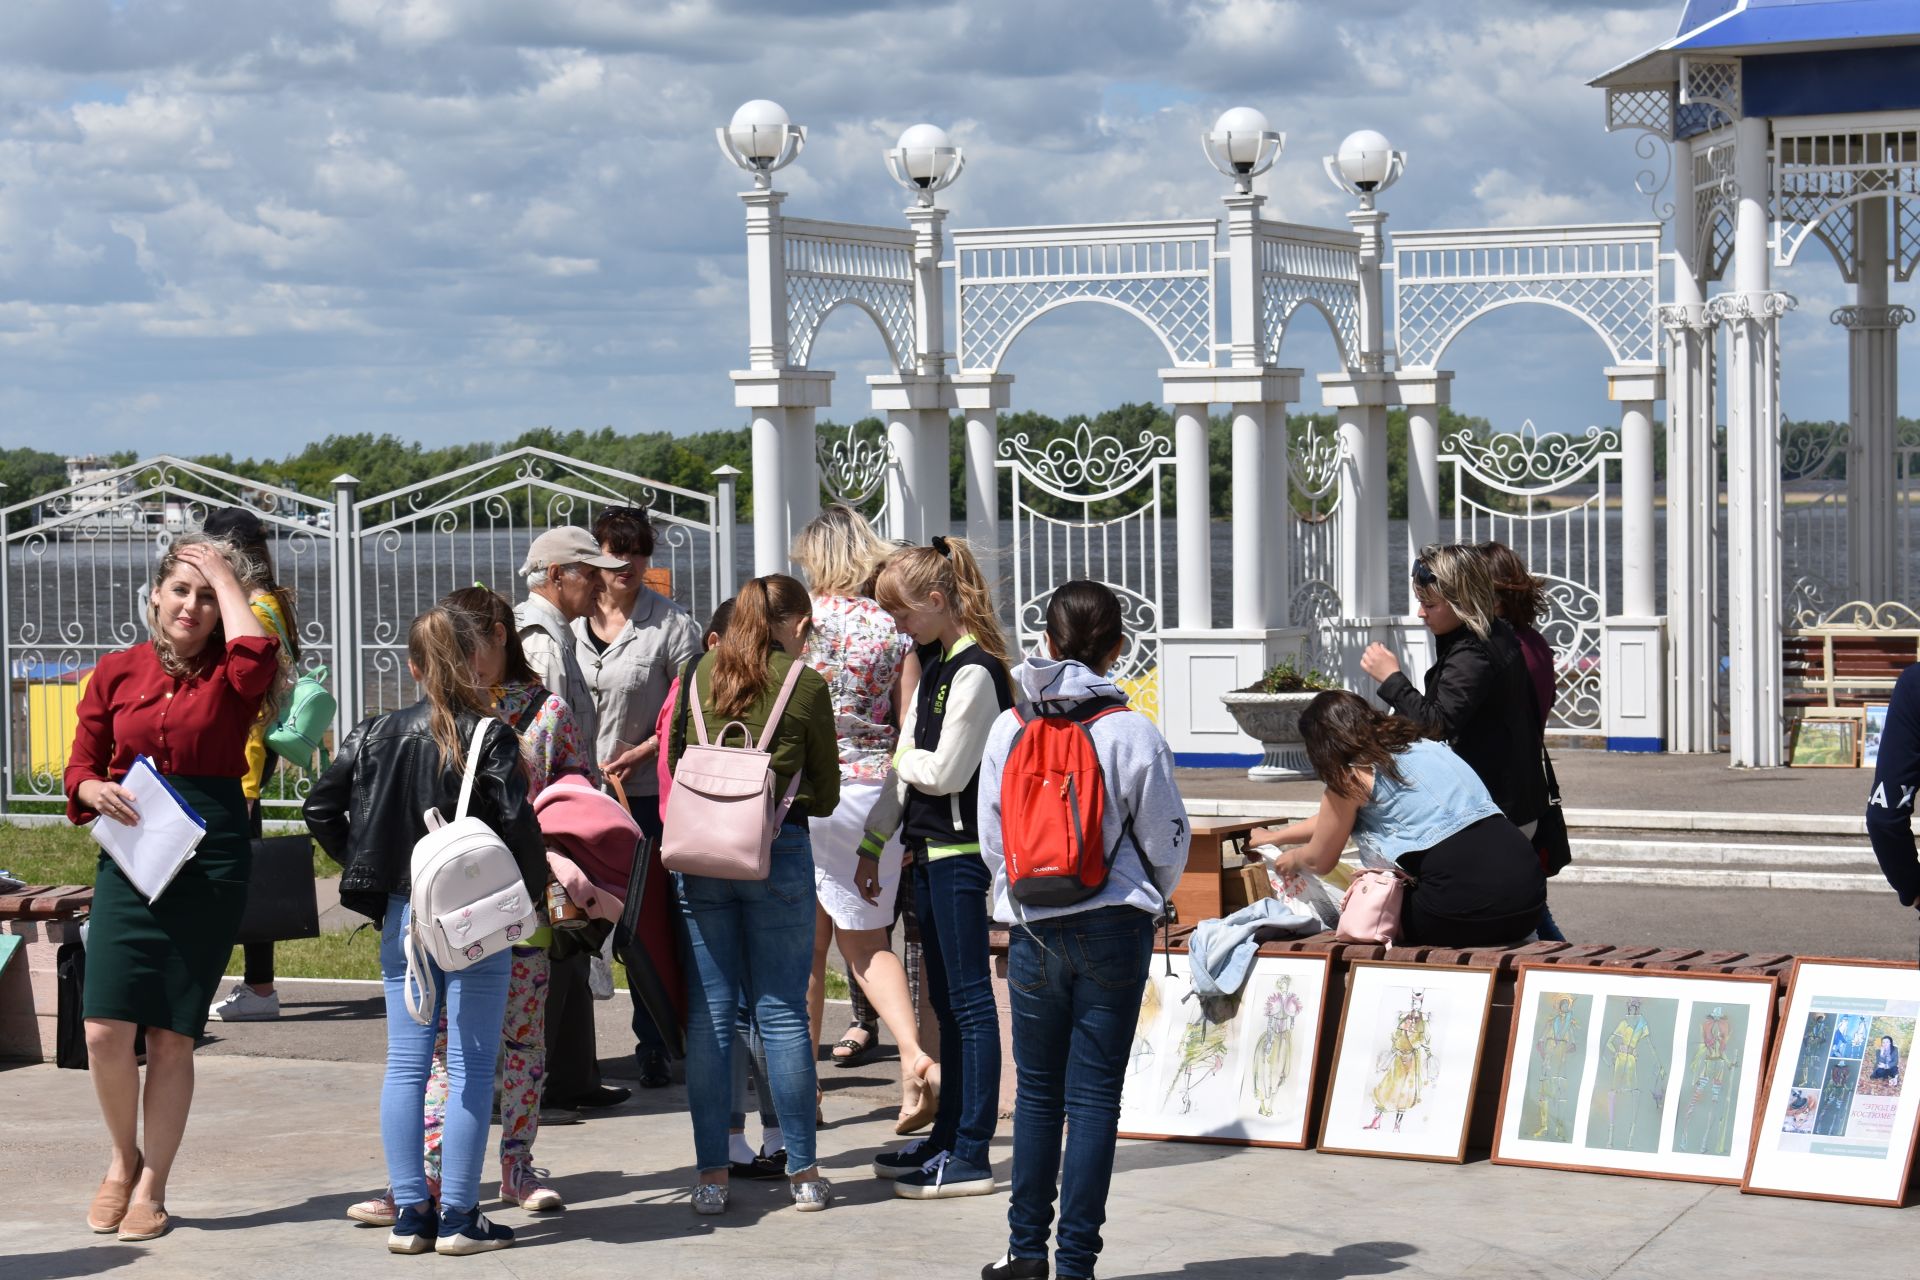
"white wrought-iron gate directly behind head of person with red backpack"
995,422,1173,723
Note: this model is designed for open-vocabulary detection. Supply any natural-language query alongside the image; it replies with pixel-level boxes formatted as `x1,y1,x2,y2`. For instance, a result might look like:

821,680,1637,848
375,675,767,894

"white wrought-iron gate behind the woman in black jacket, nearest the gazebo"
1440,422,1620,733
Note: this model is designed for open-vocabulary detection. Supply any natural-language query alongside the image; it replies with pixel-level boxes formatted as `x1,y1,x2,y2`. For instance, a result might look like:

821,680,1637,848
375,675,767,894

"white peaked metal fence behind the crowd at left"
0,449,735,812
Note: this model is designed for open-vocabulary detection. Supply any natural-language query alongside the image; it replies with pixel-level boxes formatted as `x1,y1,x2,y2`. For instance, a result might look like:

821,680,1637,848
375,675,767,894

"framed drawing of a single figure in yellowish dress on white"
1319,960,1494,1165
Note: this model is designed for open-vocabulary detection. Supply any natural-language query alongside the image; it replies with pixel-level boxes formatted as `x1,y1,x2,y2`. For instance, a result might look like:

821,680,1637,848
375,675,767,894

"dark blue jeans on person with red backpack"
1006,906,1154,1276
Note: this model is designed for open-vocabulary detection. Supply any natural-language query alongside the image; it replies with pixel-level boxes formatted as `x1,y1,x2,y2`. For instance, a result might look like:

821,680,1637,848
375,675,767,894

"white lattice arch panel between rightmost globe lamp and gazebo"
1394,223,1661,368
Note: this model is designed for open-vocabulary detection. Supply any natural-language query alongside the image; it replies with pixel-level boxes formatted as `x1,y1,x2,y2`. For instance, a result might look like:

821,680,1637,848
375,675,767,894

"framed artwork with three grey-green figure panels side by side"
1494,965,1774,1186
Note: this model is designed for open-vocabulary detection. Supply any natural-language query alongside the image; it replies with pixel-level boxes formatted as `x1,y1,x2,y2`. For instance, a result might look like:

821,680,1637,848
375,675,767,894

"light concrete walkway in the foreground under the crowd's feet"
0,1055,1914,1280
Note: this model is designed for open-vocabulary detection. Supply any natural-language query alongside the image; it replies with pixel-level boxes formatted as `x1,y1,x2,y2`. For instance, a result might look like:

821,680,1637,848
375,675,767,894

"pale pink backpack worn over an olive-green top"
660,662,806,881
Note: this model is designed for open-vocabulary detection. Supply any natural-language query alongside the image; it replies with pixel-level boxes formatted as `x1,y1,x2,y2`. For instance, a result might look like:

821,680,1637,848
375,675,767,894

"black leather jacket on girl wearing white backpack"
303,700,547,923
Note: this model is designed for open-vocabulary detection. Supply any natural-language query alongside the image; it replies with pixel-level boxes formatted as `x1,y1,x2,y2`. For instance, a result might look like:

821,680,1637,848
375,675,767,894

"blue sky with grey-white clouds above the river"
0,0,1920,466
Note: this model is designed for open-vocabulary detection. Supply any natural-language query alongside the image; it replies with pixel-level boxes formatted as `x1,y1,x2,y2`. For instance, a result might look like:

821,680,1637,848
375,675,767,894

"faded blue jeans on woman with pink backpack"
674,823,816,1173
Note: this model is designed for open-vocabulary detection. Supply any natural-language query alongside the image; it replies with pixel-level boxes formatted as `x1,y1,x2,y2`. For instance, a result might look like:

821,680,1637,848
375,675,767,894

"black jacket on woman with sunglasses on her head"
1380,620,1548,827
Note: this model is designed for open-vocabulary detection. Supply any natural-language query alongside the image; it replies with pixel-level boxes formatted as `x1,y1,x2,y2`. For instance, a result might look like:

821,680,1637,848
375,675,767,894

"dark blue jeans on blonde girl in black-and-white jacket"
914,852,1006,1169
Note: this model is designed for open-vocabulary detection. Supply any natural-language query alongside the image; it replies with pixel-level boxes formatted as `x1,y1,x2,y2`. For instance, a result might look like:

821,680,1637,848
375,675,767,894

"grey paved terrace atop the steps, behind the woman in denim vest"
1179,750,1872,818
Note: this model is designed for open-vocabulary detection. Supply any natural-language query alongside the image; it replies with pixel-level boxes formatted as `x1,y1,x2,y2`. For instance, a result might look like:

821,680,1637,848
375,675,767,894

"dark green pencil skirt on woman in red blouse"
81,775,253,1038
